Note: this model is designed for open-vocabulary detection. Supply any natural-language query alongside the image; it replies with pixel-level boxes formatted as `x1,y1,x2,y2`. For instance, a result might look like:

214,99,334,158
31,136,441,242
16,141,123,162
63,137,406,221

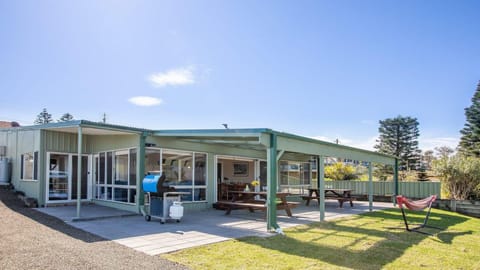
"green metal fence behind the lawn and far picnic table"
325,181,441,198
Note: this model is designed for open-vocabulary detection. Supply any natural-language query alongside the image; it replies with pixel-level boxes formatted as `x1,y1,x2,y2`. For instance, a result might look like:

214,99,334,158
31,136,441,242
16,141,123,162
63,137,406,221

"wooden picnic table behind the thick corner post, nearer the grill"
218,191,299,217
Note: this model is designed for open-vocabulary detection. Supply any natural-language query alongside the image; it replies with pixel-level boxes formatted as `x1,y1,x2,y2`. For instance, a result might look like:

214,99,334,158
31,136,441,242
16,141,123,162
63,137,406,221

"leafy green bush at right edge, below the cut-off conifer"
433,154,480,200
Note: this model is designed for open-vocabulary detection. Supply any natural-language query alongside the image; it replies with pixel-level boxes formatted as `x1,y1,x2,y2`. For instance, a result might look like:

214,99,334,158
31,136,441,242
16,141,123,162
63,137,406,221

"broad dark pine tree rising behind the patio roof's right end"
374,116,420,171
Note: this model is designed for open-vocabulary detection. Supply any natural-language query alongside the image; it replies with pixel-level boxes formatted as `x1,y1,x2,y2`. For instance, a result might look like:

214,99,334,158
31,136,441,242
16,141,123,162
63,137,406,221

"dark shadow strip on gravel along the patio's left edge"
0,189,107,243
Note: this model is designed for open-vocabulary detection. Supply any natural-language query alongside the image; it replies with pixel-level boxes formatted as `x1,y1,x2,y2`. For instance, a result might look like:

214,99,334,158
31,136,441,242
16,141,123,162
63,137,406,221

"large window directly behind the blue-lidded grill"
145,148,207,201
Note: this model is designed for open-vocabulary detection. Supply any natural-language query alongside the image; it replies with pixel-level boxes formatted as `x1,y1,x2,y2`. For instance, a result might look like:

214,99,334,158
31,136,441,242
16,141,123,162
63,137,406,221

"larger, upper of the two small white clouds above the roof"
148,66,195,87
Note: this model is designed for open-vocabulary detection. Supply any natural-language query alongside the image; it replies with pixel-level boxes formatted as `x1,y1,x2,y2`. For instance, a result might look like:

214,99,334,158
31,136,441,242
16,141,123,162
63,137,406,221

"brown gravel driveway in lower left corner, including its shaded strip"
0,187,187,270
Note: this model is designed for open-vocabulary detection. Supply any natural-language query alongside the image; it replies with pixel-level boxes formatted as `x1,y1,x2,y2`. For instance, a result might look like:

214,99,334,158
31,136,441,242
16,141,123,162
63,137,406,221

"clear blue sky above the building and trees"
0,0,480,151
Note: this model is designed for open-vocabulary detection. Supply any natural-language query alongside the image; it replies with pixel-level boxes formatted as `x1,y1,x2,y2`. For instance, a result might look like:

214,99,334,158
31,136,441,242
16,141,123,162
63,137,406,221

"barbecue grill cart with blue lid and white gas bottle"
142,175,190,224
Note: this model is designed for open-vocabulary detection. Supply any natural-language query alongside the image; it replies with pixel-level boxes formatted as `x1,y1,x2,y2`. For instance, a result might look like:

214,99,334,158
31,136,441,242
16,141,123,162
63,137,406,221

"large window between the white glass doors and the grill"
95,149,137,203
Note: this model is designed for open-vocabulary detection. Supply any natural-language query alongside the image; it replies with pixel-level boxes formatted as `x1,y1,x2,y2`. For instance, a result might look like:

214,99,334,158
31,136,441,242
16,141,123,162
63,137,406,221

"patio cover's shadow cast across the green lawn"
239,209,472,269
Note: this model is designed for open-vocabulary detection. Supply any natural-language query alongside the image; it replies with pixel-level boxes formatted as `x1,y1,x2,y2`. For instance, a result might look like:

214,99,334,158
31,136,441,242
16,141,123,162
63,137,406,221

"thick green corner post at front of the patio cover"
267,134,278,230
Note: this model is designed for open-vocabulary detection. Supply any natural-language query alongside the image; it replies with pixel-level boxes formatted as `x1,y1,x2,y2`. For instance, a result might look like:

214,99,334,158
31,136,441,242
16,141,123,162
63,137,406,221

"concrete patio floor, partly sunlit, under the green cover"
38,201,393,255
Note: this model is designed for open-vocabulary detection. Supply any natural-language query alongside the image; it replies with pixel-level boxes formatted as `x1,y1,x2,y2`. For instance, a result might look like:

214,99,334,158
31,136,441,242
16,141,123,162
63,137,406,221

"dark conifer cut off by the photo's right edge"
459,81,480,157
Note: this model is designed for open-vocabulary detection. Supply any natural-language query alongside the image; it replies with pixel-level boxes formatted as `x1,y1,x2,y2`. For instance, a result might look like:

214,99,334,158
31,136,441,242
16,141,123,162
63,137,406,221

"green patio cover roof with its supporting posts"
152,128,398,230
